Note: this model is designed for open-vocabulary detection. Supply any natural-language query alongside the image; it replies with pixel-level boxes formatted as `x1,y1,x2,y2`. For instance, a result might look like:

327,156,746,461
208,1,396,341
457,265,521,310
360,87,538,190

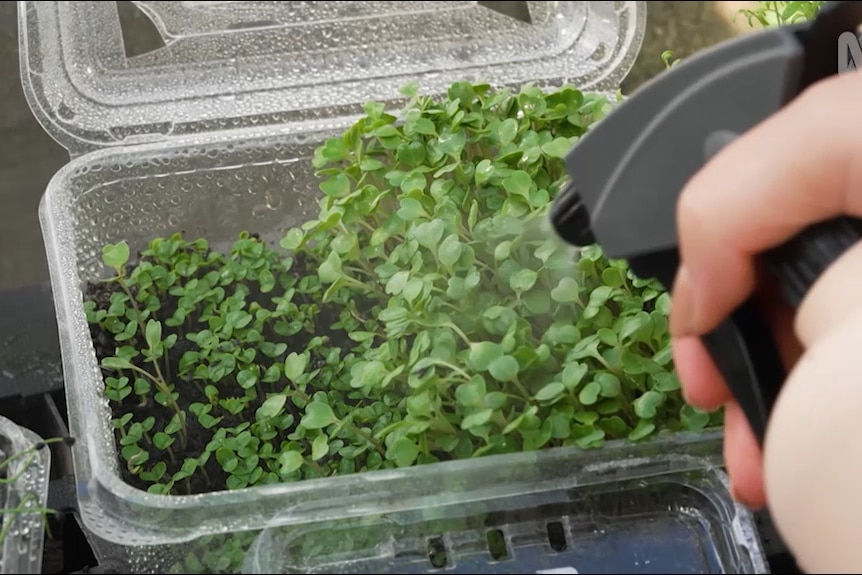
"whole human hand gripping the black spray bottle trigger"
671,73,862,572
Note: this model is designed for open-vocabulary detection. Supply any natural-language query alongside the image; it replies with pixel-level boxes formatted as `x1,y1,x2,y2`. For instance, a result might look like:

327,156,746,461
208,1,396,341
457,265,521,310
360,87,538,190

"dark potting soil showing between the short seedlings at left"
85,234,355,495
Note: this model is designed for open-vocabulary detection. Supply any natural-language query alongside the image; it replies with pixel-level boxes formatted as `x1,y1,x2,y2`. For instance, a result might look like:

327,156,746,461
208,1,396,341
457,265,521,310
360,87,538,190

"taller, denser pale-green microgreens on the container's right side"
281,82,710,454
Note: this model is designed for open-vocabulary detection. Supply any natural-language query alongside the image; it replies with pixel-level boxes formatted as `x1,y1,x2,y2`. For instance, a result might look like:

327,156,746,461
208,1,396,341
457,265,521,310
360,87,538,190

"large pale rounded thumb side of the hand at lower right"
764,307,862,573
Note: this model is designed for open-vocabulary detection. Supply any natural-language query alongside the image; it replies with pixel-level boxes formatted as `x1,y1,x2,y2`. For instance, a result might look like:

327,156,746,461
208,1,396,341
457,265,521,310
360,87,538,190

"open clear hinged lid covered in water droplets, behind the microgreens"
19,1,646,156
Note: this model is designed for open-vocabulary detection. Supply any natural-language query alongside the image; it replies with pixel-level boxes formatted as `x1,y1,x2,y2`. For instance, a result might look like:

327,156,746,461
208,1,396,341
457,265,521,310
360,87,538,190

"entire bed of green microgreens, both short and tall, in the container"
86,82,719,493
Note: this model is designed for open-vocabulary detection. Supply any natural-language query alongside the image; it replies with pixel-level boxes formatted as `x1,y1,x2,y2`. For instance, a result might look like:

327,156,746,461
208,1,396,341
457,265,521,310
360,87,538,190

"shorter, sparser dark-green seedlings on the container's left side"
85,233,383,493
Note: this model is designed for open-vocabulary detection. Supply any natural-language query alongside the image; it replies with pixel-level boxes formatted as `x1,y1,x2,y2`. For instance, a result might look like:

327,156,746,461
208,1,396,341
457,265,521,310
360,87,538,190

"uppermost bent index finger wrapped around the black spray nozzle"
671,68,862,337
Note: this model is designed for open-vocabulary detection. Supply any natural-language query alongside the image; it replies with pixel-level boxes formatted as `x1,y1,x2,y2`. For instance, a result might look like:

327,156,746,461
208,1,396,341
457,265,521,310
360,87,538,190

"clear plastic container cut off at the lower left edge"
0,417,51,573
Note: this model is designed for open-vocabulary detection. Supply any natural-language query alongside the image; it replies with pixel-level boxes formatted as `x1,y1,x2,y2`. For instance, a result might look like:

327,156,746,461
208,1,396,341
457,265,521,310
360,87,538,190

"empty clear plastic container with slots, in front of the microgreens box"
238,436,768,574
